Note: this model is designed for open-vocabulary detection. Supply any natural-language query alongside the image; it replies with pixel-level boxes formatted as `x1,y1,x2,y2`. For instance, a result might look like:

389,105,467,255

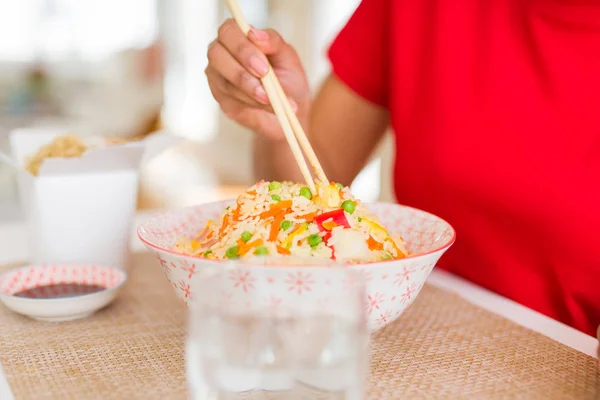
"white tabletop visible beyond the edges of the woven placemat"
0,208,598,400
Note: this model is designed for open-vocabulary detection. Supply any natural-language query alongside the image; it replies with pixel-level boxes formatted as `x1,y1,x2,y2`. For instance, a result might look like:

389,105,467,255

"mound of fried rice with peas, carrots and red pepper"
174,181,409,263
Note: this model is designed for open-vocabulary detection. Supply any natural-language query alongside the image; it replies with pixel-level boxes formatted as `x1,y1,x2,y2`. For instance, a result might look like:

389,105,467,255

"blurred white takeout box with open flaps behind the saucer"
10,129,180,269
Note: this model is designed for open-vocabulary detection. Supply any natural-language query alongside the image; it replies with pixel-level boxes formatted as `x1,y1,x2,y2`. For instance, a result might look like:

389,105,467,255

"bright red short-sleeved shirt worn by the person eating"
329,0,600,335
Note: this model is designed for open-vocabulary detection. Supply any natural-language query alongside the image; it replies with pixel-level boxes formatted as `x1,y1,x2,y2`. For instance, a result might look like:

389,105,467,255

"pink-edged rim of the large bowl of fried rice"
136,199,456,267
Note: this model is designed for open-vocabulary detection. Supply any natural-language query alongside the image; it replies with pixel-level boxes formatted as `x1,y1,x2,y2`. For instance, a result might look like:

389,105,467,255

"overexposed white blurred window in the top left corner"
0,0,158,63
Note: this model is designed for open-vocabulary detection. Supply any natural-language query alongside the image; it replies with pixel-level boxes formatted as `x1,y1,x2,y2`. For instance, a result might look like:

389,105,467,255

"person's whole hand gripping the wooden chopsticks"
205,19,310,139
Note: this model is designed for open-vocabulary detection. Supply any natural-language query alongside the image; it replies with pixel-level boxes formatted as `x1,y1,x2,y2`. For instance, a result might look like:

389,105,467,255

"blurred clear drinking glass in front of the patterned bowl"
186,264,369,400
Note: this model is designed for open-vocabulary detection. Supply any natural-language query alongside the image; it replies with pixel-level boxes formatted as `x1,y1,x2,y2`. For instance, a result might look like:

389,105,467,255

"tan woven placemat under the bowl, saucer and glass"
0,254,600,400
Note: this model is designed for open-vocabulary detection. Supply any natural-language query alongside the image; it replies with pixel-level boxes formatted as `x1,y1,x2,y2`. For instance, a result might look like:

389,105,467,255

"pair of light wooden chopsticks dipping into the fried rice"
225,0,329,193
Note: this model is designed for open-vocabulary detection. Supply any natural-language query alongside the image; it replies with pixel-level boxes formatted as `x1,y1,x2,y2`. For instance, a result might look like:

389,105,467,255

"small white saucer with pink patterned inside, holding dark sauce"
0,264,127,322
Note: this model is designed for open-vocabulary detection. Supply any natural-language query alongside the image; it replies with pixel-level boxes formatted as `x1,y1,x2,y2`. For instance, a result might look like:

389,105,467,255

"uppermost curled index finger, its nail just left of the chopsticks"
217,19,269,78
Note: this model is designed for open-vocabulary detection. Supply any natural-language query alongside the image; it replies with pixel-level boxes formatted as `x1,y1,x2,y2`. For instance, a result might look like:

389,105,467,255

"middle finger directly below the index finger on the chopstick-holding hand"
207,41,269,104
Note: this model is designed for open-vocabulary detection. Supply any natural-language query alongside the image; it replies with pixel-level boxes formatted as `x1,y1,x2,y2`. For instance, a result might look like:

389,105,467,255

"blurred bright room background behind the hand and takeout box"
0,0,390,219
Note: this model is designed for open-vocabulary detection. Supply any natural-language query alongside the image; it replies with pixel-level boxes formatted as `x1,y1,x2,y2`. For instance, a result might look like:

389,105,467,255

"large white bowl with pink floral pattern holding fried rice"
138,200,456,330
